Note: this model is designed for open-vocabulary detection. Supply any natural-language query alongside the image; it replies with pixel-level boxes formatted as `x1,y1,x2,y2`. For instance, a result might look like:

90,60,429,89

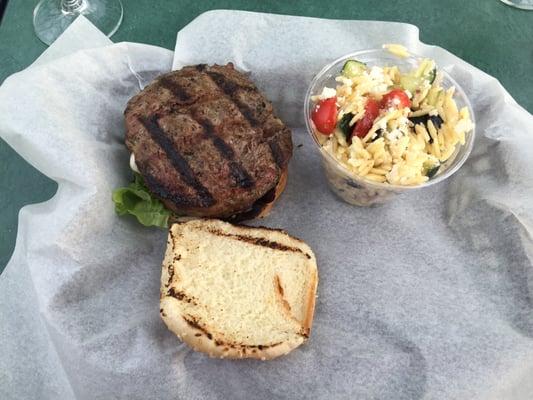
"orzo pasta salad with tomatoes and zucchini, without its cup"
311,46,473,185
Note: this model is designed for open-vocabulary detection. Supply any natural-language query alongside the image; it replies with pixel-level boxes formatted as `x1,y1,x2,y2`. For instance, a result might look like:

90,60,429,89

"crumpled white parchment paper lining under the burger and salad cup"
0,11,533,400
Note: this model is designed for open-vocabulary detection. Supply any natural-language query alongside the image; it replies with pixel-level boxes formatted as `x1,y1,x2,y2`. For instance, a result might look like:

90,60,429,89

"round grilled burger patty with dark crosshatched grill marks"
124,64,292,218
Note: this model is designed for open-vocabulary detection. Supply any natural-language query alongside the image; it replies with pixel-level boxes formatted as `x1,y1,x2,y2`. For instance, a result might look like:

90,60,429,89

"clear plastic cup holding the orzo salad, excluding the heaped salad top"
304,49,475,206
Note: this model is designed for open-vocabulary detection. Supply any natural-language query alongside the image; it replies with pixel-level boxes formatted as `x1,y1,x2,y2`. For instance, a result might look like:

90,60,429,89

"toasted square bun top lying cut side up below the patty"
160,220,318,360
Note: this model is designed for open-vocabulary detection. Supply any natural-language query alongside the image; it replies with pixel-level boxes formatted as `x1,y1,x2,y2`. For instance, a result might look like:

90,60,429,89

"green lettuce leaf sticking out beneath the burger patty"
113,173,172,228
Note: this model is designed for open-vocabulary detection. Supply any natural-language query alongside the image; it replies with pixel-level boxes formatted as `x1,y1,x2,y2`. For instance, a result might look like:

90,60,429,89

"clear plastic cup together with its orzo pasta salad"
306,45,474,205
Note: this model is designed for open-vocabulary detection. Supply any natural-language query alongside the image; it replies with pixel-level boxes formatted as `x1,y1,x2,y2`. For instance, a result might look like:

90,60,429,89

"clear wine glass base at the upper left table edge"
33,0,123,45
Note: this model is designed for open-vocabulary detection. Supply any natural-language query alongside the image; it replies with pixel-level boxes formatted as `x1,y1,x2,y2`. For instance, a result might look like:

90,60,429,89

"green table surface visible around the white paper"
0,0,533,271
